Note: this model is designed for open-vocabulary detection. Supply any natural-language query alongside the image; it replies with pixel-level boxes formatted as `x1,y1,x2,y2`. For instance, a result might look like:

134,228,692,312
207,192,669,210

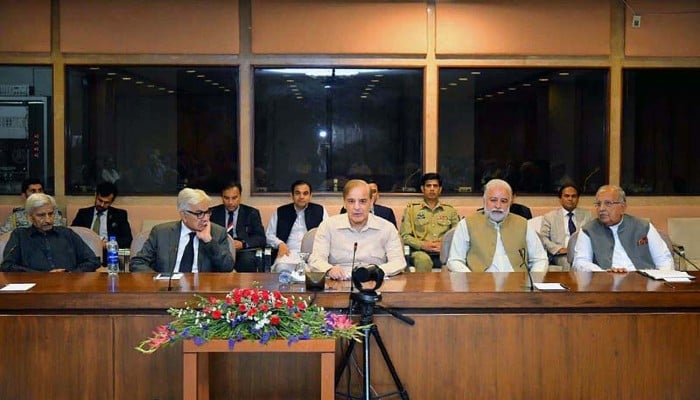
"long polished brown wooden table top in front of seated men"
0,272,700,313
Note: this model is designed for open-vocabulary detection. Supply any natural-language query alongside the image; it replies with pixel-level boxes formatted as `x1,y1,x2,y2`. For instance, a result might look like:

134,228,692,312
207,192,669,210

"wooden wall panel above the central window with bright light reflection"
252,0,428,54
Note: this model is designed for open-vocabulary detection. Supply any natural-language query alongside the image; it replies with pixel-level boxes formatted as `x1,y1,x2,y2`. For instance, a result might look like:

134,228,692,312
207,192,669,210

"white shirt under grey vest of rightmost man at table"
572,217,673,271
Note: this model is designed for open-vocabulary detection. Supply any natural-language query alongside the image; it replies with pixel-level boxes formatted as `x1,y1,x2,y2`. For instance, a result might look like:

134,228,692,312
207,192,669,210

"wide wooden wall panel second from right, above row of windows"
435,0,610,56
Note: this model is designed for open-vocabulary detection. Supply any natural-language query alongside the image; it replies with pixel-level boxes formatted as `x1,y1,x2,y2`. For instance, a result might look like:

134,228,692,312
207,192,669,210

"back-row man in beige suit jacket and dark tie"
539,183,593,271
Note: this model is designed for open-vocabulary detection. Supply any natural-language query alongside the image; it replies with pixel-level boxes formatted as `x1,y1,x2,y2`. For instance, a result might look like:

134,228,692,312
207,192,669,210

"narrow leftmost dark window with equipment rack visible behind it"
0,65,54,194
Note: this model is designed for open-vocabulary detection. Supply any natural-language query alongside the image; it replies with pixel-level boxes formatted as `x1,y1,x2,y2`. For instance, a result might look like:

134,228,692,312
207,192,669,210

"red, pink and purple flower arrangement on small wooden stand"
136,288,364,353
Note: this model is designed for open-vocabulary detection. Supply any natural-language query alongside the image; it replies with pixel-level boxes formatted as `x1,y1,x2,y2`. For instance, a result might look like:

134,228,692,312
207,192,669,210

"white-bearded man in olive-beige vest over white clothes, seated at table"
447,179,548,272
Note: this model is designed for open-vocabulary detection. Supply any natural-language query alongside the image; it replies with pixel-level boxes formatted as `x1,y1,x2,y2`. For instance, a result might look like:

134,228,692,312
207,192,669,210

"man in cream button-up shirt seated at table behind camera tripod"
309,179,406,279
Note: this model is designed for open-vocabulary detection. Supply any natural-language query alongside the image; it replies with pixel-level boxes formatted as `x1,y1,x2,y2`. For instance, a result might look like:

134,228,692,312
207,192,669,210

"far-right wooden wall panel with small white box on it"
625,0,700,57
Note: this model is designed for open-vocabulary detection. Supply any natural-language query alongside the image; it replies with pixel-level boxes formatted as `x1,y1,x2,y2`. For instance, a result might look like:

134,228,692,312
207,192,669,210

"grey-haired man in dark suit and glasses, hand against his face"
131,188,233,272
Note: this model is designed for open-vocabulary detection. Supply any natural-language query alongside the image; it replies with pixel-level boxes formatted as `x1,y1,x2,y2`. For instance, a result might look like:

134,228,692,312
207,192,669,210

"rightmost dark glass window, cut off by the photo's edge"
621,68,700,195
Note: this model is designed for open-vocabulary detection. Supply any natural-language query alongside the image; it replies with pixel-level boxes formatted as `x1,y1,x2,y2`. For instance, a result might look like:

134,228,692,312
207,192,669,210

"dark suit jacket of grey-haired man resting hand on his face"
131,221,233,272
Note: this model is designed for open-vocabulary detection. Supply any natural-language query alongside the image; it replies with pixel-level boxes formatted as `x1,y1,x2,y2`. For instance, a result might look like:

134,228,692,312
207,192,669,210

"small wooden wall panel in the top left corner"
0,0,51,53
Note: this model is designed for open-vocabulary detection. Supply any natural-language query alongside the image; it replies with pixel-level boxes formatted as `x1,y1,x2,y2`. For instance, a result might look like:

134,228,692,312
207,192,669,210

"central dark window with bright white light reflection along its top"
253,68,423,192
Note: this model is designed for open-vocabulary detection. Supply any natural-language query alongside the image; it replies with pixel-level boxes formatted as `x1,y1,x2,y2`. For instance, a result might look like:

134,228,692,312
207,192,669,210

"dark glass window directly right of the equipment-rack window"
66,66,239,195
